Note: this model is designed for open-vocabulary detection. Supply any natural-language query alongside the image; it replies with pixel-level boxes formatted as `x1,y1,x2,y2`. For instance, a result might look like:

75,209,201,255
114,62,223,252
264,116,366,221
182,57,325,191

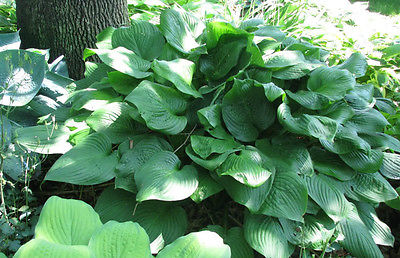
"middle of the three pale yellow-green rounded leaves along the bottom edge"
89,221,151,258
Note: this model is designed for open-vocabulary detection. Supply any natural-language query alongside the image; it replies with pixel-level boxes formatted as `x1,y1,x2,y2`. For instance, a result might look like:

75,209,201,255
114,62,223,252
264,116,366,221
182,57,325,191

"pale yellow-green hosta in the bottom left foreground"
14,196,231,258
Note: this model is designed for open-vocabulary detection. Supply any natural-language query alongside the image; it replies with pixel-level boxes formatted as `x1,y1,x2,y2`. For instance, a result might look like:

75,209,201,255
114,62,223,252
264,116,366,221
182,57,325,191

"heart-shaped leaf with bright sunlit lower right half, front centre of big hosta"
135,151,198,202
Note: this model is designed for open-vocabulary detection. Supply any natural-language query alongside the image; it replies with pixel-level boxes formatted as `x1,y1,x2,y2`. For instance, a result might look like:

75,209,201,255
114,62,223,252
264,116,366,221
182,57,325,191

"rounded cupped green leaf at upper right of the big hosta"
307,66,356,100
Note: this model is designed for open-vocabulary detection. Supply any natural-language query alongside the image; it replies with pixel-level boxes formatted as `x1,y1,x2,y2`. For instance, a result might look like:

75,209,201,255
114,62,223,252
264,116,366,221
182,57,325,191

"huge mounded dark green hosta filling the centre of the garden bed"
17,6,400,257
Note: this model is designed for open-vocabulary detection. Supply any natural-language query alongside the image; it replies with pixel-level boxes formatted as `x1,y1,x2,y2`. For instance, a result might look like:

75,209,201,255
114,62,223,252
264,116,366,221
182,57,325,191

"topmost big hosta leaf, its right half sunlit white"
160,9,205,54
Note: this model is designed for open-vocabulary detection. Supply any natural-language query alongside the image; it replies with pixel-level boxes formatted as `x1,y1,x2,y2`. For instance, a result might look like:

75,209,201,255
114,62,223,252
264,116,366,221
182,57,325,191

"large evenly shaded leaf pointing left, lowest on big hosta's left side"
44,133,118,185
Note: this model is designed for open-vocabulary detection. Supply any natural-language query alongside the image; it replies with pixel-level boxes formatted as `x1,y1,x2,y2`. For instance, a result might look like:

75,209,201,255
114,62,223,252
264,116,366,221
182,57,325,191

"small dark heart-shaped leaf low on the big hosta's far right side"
339,150,383,173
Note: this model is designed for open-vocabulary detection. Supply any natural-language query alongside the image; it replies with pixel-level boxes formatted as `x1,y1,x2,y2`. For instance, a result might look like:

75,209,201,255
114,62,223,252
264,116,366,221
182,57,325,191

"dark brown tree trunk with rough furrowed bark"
16,0,129,79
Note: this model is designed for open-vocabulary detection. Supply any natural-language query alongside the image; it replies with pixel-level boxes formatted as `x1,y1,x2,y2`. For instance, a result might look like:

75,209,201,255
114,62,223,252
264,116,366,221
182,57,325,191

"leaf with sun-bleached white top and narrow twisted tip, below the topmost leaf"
151,59,201,98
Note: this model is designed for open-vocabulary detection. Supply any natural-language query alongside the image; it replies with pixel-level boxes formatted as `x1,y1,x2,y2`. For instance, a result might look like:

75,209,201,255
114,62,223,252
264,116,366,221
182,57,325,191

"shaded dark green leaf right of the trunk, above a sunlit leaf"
111,20,165,61
